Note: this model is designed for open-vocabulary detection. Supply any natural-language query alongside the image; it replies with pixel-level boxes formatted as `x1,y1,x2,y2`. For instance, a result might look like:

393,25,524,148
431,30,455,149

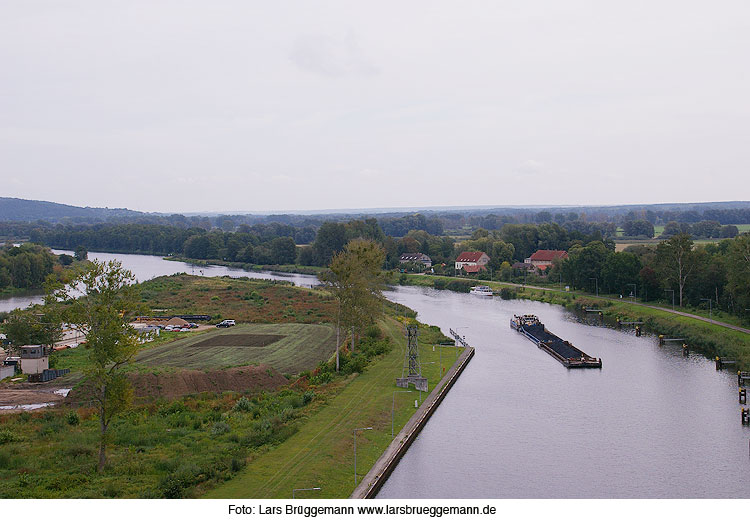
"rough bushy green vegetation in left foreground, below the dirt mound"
0,390,318,498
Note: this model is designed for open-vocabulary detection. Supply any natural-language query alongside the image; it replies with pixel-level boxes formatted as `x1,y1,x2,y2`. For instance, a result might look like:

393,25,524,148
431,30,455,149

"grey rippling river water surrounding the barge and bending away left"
0,252,750,498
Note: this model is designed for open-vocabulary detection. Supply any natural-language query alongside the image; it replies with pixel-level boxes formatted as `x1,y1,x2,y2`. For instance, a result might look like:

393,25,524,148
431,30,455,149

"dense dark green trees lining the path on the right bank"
549,233,750,313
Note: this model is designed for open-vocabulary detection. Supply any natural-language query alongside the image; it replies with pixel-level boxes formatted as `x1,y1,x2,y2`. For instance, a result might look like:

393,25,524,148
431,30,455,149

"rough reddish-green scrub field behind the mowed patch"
138,274,336,323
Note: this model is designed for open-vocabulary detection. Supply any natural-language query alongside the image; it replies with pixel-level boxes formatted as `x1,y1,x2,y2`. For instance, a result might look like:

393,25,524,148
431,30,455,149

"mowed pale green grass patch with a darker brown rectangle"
136,323,336,374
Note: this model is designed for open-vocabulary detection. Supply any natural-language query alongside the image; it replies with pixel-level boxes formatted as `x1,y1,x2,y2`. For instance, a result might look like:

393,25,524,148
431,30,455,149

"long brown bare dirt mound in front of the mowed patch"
128,365,289,398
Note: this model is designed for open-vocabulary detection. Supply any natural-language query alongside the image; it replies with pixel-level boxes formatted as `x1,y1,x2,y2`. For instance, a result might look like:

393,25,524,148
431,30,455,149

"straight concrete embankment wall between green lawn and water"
349,346,474,499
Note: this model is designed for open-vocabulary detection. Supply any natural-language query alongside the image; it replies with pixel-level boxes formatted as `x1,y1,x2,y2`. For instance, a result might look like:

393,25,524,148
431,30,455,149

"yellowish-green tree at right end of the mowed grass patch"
320,239,385,371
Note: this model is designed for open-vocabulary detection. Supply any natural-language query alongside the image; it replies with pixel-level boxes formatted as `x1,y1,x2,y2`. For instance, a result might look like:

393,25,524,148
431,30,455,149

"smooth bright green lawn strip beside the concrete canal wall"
207,322,456,498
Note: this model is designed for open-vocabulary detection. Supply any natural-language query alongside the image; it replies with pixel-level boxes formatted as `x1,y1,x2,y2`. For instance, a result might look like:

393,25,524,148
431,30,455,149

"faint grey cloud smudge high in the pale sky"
289,32,379,78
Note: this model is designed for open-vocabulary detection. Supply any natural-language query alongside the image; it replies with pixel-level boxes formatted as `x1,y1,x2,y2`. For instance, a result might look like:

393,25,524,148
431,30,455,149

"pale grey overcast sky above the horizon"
0,0,750,212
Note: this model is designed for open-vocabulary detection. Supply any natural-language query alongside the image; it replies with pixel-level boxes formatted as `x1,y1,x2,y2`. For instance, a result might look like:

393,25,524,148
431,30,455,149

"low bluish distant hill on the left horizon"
0,197,147,222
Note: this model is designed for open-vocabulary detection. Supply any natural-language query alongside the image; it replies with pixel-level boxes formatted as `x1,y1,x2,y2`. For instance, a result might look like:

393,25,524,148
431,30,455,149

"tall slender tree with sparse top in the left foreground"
54,261,142,472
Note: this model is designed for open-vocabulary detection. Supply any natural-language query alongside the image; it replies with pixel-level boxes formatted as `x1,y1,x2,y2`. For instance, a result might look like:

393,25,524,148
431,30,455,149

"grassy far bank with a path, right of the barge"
401,274,750,369
